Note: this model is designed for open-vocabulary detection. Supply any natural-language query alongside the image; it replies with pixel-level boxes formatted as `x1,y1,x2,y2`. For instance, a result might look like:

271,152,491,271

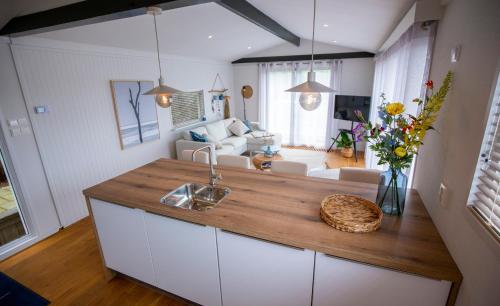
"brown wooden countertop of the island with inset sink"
83,159,462,284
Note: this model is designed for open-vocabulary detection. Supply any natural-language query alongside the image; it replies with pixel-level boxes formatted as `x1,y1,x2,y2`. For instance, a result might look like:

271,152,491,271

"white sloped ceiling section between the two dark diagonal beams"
36,3,283,60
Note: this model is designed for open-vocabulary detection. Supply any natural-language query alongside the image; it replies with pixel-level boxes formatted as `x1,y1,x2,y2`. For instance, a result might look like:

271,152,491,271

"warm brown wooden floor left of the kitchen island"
0,218,189,306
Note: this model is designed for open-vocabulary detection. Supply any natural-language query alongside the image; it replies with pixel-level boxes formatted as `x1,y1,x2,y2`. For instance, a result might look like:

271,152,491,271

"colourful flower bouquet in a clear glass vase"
356,72,453,215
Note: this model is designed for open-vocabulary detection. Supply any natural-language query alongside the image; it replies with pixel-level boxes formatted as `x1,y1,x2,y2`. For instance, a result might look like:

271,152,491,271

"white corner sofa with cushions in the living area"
176,117,281,163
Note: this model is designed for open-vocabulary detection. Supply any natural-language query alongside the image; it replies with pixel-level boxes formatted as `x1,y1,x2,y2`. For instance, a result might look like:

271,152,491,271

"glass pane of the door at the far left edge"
0,143,28,247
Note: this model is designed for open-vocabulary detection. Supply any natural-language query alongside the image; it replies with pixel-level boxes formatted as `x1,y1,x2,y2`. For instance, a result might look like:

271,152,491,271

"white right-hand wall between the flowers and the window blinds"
414,0,500,306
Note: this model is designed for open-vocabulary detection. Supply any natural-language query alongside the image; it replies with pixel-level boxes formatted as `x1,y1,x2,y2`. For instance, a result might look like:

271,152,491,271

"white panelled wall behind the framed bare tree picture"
12,39,232,226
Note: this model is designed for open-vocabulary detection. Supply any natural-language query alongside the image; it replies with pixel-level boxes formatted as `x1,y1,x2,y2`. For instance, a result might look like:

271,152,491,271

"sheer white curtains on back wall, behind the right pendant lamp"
259,61,341,148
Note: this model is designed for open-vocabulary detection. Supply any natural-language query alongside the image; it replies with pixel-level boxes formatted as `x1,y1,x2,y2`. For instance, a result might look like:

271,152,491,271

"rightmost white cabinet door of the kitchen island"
313,253,451,306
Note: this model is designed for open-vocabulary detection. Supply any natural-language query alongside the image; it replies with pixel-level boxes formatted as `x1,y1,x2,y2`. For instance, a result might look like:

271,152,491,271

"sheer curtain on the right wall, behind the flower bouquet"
365,22,437,178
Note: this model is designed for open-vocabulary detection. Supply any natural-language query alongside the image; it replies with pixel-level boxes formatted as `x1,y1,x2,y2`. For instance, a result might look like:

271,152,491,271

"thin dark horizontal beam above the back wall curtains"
232,52,375,64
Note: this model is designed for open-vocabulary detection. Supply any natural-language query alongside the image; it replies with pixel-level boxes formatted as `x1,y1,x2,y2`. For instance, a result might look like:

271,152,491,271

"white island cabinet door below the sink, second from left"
146,213,221,306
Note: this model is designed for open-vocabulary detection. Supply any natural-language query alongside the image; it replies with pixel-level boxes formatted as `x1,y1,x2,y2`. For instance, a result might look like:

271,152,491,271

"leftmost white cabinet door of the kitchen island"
90,199,155,285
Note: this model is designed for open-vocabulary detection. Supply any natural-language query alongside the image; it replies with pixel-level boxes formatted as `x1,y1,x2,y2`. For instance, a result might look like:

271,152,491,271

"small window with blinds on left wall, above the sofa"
172,90,205,128
